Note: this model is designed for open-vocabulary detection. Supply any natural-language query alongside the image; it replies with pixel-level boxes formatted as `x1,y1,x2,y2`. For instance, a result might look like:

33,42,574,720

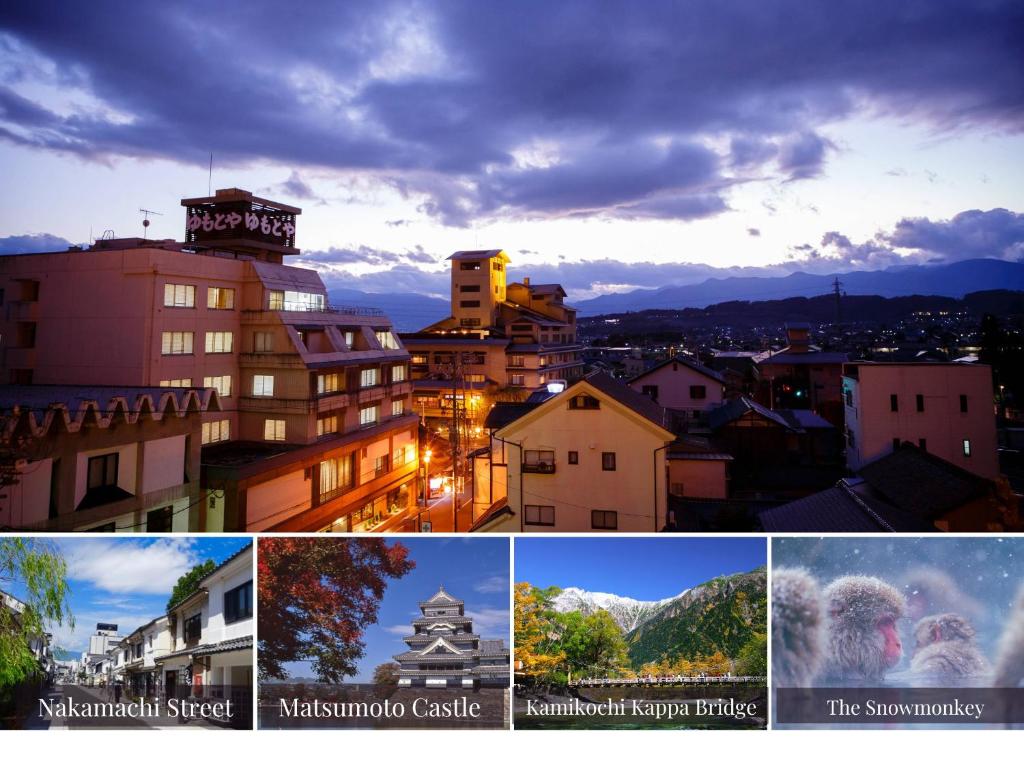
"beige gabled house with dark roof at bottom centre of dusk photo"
472,373,675,532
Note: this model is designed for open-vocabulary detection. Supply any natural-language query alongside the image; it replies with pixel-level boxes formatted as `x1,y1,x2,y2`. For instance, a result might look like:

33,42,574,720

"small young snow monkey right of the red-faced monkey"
910,613,988,682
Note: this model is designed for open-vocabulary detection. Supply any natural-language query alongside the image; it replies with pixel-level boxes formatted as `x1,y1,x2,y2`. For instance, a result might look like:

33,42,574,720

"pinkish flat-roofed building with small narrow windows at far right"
843,362,999,479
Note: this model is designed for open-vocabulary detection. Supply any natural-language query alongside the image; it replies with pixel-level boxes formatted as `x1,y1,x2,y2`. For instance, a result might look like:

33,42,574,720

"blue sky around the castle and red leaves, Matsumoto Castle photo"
280,537,511,682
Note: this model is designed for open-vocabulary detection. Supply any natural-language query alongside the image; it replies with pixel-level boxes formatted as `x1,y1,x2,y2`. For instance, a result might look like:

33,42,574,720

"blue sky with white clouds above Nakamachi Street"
4,537,252,654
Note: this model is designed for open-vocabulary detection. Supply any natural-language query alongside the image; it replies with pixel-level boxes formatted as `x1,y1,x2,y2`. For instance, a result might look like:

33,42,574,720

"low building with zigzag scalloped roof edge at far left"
0,386,220,532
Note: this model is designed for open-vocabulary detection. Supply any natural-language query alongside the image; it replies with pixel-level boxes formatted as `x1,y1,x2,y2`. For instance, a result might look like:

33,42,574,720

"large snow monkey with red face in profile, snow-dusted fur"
824,575,906,682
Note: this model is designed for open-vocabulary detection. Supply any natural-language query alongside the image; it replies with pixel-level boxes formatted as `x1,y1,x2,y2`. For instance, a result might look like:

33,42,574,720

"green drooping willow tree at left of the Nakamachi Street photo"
0,538,75,688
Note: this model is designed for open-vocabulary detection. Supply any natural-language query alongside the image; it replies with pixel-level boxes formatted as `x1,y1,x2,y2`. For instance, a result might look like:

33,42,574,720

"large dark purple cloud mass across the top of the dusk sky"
0,0,1024,225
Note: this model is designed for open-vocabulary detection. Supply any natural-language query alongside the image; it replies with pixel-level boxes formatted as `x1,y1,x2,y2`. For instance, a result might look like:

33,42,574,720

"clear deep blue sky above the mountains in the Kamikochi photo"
515,537,767,600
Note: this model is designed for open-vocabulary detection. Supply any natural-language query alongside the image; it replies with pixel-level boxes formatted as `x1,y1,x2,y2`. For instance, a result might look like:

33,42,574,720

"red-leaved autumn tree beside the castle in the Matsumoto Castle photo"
257,537,416,683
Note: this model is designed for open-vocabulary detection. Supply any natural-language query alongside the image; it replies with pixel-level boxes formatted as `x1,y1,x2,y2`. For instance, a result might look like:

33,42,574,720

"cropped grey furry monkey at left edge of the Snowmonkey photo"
771,568,825,688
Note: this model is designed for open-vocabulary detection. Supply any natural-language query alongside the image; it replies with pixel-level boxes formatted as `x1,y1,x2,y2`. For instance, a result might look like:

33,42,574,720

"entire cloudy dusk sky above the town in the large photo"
0,0,1024,300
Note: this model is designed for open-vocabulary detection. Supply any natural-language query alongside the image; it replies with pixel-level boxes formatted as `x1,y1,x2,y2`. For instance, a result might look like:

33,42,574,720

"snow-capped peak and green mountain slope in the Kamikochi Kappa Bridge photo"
552,567,768,667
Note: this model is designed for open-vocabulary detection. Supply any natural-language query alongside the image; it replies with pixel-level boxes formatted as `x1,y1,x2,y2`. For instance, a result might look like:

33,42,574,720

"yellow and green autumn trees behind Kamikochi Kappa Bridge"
513,582,768,688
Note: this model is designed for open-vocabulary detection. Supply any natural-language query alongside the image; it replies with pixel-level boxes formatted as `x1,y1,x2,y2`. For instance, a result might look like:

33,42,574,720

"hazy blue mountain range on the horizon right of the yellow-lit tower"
569,259,1024,315
